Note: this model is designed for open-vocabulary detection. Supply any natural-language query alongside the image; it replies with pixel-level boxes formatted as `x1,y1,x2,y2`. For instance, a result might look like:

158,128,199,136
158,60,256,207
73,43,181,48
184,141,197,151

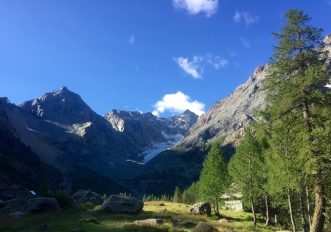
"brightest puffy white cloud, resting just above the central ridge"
153,91,205,116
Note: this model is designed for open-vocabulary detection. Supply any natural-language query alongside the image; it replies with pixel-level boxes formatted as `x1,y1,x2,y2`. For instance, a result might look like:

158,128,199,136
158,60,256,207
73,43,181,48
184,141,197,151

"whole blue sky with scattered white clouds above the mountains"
0,0,331,116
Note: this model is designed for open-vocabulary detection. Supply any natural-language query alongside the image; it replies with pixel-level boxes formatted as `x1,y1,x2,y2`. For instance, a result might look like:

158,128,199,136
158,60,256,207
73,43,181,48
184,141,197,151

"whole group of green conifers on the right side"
173,9,331,232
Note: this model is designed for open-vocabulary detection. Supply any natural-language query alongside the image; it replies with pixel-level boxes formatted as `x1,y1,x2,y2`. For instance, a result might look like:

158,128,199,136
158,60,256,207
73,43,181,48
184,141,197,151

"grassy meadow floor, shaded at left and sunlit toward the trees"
0,201,279,232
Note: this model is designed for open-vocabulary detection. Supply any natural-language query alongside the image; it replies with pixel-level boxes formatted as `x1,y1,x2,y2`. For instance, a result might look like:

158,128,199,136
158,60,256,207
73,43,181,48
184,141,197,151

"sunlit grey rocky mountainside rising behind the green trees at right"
176,65,269,149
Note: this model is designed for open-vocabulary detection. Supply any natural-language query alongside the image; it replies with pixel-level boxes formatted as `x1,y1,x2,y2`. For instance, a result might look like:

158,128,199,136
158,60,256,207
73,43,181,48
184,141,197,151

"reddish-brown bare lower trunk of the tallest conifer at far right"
310,180,325,232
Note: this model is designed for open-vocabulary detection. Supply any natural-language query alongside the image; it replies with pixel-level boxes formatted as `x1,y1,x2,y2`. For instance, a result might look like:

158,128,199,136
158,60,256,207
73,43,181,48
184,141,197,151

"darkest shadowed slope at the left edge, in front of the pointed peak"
0,98,64,193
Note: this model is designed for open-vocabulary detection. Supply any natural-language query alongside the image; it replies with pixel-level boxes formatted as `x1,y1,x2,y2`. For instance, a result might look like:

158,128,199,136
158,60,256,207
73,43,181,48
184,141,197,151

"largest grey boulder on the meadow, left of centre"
99,195,144,213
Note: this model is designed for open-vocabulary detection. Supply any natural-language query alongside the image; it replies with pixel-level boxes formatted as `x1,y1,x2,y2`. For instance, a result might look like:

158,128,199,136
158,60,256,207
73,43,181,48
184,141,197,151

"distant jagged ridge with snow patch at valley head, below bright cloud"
105,110,197,162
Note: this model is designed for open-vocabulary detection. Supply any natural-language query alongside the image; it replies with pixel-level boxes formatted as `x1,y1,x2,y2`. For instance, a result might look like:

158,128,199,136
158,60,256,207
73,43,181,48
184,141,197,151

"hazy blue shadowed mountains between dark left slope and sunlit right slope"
0,87,197,193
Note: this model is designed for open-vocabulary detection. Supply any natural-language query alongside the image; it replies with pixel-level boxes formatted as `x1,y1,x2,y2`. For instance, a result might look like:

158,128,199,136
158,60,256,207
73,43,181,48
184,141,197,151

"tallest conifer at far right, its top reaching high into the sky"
266,9,330,232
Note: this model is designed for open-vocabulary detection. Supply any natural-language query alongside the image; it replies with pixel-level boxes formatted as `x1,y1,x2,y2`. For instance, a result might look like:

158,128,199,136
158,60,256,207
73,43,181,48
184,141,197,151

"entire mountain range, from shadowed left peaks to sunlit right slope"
0,35,331,195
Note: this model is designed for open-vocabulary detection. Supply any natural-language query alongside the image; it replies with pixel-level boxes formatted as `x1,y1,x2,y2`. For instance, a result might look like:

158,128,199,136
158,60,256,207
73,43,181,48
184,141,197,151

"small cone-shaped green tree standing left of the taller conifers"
199,143,229,216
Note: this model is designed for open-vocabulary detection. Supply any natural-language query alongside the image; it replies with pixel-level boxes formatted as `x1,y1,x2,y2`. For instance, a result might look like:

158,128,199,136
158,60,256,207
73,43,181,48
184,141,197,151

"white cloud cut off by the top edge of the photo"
172,0,218,17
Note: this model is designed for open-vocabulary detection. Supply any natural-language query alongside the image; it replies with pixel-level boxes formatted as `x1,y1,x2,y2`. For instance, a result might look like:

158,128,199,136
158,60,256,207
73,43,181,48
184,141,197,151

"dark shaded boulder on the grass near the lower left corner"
27,197,60,213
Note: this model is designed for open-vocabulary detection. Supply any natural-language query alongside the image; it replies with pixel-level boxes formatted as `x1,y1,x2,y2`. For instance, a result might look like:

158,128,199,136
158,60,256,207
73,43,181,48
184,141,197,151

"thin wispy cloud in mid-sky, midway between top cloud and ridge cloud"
173,53,230,79
